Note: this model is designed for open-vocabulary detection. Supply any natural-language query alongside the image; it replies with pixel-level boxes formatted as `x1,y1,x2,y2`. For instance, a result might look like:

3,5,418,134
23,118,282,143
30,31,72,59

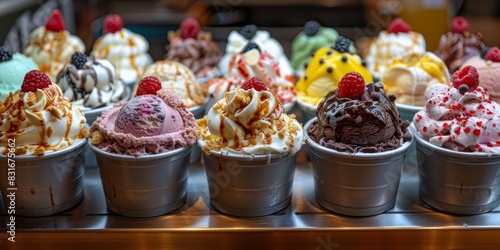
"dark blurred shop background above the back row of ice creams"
0,0,500,60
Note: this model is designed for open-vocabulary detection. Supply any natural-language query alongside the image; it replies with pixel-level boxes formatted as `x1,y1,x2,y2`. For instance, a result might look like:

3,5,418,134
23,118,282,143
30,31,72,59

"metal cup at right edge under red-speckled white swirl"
410,123,500,215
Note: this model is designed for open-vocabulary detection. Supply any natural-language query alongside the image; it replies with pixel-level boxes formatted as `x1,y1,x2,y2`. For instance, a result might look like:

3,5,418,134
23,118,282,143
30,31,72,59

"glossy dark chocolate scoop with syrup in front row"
308,78,411,152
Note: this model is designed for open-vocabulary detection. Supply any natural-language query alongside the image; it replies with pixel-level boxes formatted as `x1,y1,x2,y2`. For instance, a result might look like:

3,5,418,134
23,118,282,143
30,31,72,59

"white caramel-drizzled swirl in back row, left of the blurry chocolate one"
90,28,153,84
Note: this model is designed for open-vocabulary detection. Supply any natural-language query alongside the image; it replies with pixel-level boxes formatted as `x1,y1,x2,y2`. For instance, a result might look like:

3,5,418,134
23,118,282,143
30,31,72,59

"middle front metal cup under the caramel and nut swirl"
203,151,297,217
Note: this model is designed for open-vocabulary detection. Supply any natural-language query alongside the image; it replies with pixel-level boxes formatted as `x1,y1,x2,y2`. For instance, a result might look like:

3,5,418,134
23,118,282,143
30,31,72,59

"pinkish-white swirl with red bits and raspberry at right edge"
413,66,500,155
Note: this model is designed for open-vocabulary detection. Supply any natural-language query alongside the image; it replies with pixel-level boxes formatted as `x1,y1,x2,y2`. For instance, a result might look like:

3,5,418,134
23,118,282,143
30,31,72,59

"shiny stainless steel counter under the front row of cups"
0,142,500,250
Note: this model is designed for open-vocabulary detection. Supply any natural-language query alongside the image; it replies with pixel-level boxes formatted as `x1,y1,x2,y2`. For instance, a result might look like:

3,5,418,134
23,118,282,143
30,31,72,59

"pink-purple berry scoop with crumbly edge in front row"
90,90,197,156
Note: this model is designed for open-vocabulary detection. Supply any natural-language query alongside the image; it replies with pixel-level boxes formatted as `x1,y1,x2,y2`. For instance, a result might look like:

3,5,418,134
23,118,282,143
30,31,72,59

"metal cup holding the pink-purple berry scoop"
88,141,191,217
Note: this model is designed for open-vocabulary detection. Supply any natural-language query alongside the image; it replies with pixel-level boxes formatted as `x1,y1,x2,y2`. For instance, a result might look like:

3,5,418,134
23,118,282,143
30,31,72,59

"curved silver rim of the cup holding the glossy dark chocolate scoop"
303,117,415,159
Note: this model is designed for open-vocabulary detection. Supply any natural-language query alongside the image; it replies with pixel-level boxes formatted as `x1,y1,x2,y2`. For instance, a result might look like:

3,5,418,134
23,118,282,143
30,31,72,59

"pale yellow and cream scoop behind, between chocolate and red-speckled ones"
382,52,450,106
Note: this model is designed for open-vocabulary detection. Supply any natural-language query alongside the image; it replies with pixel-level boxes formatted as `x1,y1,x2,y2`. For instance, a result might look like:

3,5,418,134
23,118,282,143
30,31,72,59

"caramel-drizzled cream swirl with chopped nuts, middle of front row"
197,79,303,154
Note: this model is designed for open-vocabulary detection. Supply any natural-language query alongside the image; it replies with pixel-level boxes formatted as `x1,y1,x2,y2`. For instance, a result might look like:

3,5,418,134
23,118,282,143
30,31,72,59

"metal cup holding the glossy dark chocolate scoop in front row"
304,118,411,216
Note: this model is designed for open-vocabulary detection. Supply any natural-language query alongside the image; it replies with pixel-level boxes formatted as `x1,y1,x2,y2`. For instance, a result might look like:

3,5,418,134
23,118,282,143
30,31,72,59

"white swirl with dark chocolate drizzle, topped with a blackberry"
57,53,127,110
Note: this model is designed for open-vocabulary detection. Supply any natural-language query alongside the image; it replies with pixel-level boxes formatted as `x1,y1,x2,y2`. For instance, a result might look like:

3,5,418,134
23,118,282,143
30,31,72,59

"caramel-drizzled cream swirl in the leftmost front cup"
0,84,87,156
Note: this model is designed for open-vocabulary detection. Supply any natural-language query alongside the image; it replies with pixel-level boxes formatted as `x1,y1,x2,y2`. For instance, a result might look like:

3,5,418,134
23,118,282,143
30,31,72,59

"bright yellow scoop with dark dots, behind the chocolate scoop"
295,47,373,106
